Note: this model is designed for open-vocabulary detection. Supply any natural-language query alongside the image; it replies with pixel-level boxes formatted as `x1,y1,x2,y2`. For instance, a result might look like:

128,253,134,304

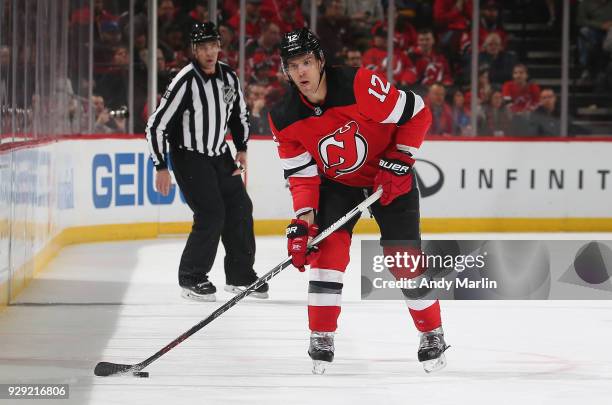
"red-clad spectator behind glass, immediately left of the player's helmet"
245,22,282,87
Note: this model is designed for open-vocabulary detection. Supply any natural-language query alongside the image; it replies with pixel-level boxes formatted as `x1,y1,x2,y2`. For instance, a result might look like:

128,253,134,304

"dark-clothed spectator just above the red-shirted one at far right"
474,32,516,86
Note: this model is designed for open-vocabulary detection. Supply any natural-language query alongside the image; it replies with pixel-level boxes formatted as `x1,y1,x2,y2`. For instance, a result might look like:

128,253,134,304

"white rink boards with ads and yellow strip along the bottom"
0,135,612,304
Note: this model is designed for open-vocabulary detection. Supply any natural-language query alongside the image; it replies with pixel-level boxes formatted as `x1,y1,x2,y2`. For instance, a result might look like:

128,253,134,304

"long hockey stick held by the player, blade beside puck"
94,189,382,377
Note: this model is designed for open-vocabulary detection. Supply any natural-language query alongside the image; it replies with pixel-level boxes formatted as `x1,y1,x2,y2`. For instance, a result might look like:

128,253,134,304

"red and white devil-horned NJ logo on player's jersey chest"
319,121,368,178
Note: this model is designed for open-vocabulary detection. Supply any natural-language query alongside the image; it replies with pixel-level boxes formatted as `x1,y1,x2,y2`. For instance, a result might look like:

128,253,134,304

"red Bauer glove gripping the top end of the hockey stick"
374,151,414,205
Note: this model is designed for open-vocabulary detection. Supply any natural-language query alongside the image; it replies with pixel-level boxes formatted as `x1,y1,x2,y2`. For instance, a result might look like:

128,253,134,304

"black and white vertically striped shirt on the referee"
146,61,249,170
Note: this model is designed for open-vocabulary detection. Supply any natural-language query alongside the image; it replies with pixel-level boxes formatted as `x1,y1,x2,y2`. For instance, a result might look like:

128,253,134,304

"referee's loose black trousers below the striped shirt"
170,148,257,286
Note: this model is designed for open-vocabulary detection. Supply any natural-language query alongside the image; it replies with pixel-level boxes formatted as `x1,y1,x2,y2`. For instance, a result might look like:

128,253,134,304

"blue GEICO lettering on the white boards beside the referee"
91,153,185,208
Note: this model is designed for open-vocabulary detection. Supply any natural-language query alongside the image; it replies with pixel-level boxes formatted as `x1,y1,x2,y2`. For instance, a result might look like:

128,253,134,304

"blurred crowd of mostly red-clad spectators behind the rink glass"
0,0,612,136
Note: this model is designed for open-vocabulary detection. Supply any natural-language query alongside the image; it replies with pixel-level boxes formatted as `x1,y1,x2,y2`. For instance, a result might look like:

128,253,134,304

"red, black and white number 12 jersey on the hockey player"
269,67,431,215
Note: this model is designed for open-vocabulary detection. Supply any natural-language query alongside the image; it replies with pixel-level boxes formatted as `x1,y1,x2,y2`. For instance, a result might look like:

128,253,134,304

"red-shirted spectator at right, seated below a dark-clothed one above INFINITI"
502,63,540,114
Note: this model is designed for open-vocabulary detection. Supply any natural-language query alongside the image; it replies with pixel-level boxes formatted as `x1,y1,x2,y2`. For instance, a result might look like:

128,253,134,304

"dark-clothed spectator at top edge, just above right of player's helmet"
317,0,352,65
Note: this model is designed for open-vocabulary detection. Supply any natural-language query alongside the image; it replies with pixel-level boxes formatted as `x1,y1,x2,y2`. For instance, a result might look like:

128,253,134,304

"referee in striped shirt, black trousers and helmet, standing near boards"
146,22,268,301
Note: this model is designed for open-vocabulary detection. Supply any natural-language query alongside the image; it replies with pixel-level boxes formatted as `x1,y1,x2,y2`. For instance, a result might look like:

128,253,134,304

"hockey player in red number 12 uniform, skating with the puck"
269,28,447,374
